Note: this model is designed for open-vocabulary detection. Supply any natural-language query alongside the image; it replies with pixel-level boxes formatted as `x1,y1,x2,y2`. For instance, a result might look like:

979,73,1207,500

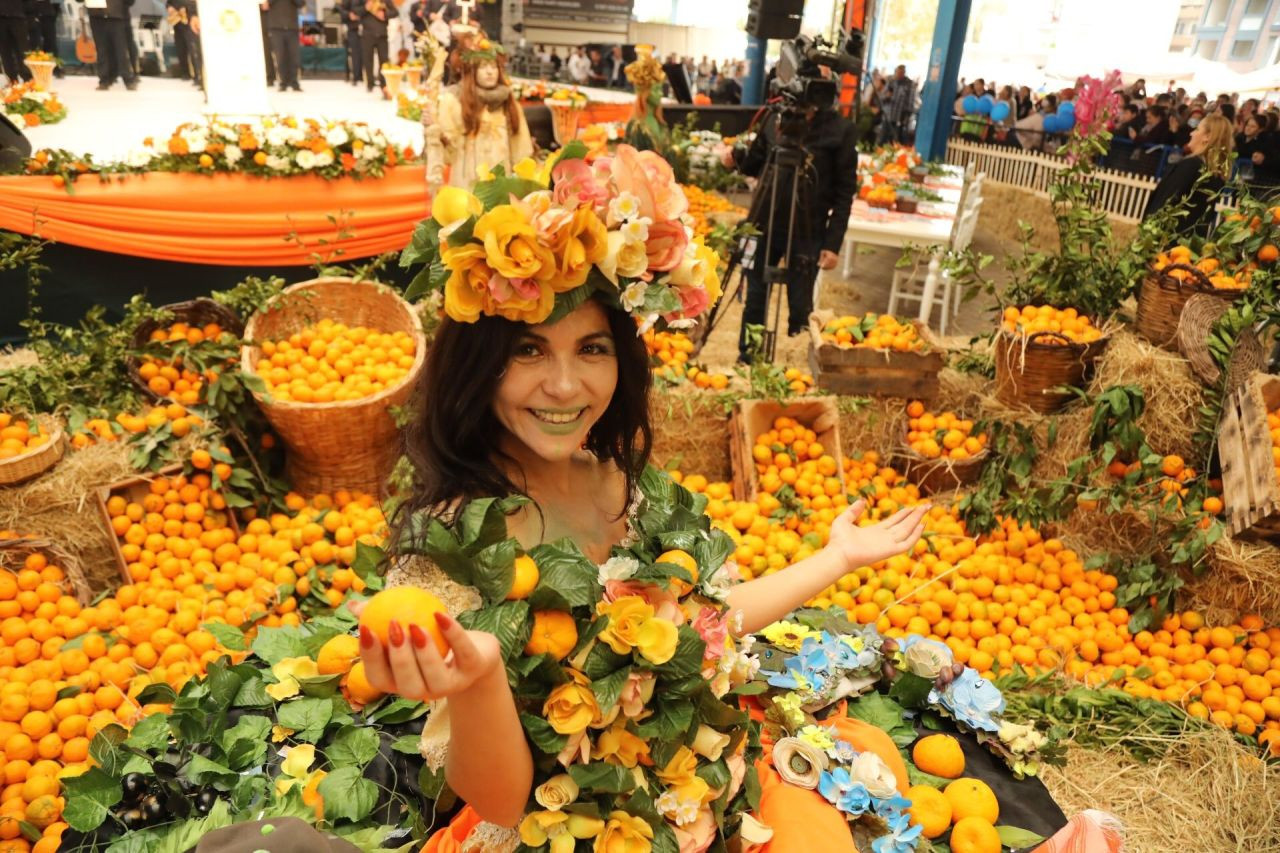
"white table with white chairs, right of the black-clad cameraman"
840,165,964,321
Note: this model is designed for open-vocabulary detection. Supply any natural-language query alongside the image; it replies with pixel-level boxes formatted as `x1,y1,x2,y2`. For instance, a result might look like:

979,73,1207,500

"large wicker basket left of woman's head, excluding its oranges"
241,278,426,494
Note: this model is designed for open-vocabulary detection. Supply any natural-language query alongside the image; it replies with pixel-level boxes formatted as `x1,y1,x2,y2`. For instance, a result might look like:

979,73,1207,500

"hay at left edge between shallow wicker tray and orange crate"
0,442,134,594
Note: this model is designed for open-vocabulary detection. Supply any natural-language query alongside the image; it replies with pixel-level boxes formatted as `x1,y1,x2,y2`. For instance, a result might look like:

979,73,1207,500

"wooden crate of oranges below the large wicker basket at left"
96,466,239,584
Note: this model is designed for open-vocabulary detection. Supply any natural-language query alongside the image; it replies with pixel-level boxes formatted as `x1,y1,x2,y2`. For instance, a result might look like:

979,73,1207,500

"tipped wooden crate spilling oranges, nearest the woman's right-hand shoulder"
728,397,845,501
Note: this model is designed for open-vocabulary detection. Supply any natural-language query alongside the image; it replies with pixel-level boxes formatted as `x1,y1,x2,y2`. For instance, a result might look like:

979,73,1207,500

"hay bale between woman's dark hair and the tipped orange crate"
649,388,733,483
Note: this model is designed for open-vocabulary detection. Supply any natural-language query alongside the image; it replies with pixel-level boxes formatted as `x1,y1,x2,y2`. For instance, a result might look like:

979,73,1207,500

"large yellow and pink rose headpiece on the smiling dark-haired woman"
401,141,721,332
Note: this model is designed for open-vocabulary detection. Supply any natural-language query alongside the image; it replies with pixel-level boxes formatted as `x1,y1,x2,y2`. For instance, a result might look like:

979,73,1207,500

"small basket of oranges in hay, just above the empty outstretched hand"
896,400,989,494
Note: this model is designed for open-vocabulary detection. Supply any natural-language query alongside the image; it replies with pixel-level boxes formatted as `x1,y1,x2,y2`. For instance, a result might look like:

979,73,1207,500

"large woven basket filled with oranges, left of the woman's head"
241,278,426,493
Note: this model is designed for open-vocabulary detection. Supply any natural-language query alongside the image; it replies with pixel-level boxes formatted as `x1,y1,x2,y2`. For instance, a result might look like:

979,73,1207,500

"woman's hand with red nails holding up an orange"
349,602,506,701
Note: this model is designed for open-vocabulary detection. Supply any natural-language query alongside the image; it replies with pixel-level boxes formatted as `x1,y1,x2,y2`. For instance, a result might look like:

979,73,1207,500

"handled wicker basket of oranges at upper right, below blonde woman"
1134,246,1248,351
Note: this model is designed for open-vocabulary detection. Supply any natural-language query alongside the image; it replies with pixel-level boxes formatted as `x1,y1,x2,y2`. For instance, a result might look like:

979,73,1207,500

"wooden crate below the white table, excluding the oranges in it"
809,310,946,402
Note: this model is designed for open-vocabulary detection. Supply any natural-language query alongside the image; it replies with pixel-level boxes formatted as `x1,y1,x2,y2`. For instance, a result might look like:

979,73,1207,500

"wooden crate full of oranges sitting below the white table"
809,310,945,401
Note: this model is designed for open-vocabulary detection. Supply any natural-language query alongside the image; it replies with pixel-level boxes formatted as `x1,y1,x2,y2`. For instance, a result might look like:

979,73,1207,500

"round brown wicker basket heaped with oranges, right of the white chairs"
996,305,1108,414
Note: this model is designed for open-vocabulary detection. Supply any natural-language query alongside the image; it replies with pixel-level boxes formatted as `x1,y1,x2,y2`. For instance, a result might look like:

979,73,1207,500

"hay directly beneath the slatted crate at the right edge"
1185,538,1280,625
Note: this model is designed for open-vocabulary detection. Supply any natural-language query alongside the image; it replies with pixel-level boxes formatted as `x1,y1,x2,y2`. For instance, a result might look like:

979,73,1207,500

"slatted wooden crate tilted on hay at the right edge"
1217,373,1280,539
